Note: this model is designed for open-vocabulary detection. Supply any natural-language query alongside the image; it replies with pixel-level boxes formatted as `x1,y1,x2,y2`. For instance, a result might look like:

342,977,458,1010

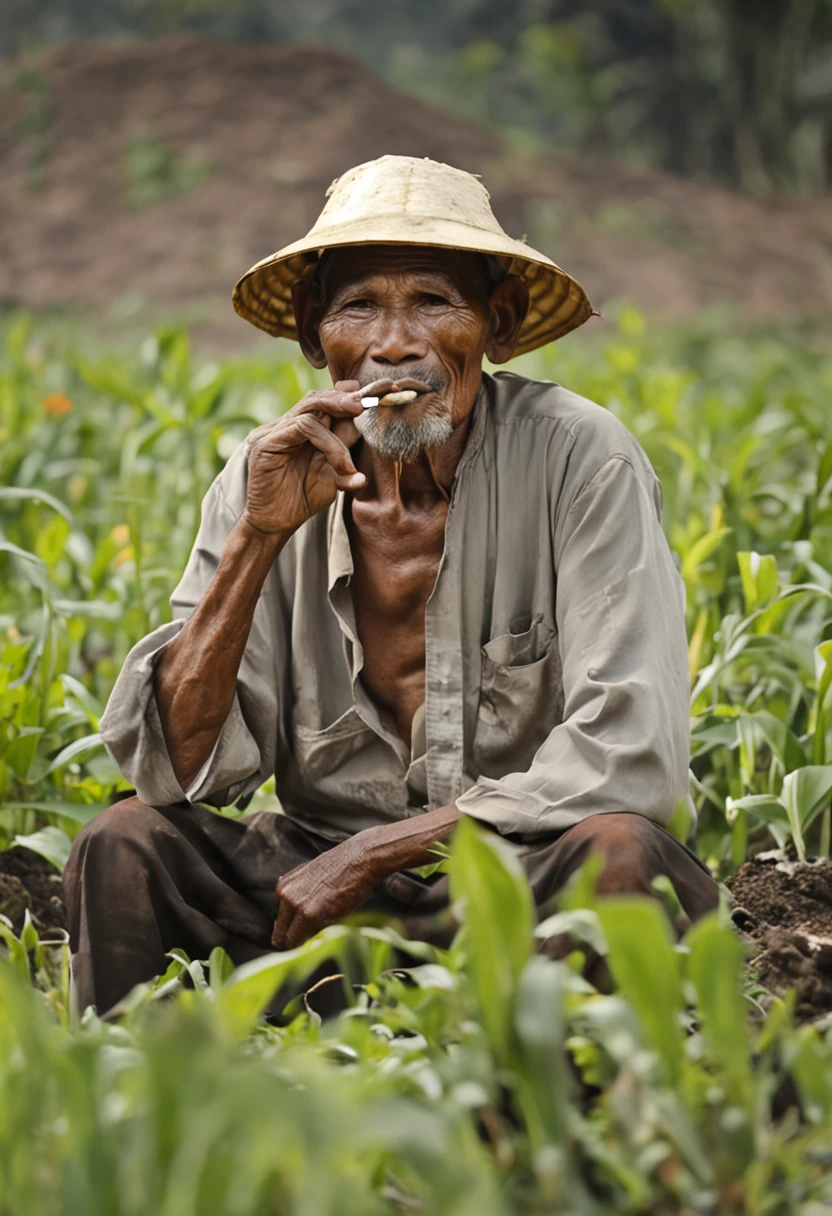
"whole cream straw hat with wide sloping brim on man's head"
232,156,594,355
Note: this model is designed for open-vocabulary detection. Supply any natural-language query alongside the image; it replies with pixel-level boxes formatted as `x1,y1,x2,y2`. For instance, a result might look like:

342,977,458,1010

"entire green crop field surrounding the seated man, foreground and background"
0,309,832,1216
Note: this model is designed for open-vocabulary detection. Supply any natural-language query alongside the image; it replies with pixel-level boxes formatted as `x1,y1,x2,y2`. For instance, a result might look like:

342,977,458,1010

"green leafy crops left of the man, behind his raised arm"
0,317,321,851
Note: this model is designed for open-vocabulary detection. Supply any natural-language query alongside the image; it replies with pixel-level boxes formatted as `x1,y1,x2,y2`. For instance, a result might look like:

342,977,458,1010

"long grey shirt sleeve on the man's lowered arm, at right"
456,455,690,837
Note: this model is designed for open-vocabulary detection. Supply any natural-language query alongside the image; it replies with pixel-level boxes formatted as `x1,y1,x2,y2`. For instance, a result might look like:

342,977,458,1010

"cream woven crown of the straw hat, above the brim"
309,156,505,237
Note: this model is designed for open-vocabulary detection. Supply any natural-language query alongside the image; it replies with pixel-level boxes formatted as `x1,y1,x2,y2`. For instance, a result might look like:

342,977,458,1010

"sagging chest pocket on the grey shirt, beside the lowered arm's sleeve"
473,615,563,778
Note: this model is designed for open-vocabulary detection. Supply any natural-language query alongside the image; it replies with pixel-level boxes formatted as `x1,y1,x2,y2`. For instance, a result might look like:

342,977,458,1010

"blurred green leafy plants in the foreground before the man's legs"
0,822,832,1216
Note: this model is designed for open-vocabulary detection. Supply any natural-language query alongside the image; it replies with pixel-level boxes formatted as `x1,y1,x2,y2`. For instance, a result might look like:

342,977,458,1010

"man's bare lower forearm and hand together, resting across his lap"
271,804,460,950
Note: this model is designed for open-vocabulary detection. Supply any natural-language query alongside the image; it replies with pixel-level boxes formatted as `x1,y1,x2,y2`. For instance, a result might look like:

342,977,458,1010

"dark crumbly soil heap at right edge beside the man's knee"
726,854,832,1021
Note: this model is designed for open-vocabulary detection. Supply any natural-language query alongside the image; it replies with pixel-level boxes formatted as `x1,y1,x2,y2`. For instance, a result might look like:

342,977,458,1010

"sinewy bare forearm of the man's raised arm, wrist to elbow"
154,519,288,789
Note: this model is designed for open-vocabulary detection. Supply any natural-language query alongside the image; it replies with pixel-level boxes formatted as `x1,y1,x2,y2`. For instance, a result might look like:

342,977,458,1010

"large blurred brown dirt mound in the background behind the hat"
0,35,832,344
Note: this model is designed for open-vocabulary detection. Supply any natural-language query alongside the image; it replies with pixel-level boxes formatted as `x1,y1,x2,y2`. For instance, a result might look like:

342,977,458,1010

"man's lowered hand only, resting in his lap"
271,833,380,950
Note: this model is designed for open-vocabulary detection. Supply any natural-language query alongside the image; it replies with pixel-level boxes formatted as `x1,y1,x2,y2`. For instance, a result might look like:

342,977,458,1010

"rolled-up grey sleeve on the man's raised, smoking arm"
101,471,280,806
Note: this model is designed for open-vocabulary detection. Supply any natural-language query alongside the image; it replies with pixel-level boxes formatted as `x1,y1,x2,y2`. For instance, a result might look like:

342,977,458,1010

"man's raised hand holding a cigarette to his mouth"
242,379,395,536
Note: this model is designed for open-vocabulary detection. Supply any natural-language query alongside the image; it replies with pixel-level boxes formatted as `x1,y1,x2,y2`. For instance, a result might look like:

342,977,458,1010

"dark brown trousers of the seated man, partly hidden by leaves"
63,798,718,1013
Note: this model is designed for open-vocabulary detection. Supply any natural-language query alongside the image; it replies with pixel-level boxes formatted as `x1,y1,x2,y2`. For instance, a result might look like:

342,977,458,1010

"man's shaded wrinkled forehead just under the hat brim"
315,244,490,298
